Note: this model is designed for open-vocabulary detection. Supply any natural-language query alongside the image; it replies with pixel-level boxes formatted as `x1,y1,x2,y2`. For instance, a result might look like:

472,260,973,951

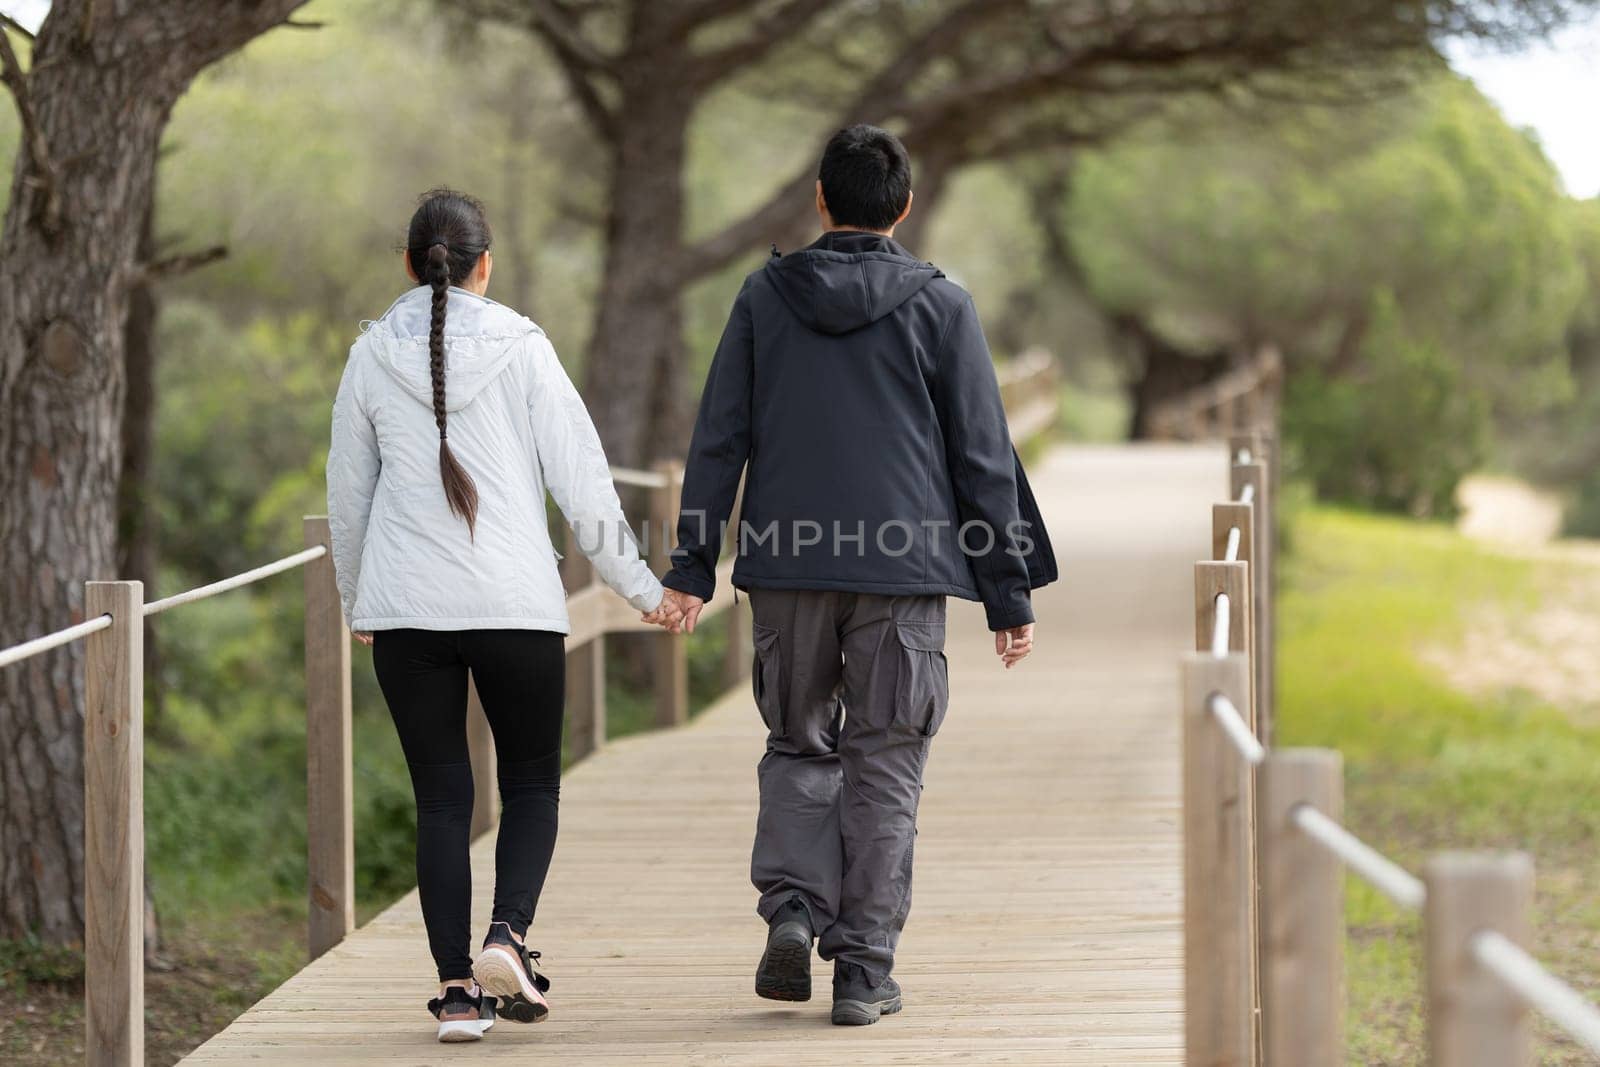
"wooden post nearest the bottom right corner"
1422,853,1533,1067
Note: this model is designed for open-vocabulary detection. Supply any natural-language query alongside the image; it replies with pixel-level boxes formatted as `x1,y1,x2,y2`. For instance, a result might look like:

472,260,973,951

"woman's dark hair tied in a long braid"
405,189,491,536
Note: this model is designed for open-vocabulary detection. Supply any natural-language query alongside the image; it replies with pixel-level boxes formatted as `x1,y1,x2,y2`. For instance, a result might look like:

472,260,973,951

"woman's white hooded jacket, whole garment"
328,286,661,633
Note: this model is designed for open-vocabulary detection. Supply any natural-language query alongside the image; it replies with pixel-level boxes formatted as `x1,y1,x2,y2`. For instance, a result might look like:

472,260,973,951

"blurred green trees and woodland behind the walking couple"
0,0,1600,1062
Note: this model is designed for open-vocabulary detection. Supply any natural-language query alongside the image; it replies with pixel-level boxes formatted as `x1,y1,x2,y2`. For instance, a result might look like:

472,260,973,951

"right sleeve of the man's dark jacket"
934,298,1034,630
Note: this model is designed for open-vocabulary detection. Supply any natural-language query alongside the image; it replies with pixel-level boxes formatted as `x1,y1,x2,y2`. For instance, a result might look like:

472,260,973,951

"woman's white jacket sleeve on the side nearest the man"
528,333,661,611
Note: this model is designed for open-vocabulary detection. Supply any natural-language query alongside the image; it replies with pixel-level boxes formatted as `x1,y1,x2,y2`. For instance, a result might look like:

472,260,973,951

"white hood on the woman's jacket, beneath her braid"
362,285,544,411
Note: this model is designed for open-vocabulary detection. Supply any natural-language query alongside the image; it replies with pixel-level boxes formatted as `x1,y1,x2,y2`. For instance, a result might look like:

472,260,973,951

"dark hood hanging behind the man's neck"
766,230,944,334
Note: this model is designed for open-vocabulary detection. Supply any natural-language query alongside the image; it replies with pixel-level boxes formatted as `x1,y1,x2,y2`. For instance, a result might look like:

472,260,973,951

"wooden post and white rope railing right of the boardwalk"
1182,428,1600,1067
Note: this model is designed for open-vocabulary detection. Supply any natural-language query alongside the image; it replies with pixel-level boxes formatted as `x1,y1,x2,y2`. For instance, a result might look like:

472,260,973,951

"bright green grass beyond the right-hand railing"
1278,507,1600,1065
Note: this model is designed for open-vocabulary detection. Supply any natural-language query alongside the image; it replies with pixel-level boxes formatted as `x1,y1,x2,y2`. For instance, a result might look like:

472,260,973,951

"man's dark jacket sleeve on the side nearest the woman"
662,282,755,600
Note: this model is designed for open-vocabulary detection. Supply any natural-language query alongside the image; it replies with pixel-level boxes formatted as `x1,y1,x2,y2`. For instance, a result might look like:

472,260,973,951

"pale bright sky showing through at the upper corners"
0,0,1600,197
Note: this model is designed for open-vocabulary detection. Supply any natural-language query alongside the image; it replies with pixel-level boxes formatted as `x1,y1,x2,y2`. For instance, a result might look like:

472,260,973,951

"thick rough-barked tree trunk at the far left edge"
0,0,298,942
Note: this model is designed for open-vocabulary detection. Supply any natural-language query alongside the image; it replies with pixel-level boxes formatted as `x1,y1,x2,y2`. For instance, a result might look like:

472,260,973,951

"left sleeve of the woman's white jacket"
328,354,382,624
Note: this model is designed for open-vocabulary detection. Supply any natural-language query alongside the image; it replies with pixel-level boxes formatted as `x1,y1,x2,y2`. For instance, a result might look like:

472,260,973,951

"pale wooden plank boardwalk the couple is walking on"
181,446,1227,1067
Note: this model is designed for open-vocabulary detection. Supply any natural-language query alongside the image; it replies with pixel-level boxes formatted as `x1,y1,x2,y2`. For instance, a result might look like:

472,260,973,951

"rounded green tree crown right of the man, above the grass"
1070,74,1584,514
